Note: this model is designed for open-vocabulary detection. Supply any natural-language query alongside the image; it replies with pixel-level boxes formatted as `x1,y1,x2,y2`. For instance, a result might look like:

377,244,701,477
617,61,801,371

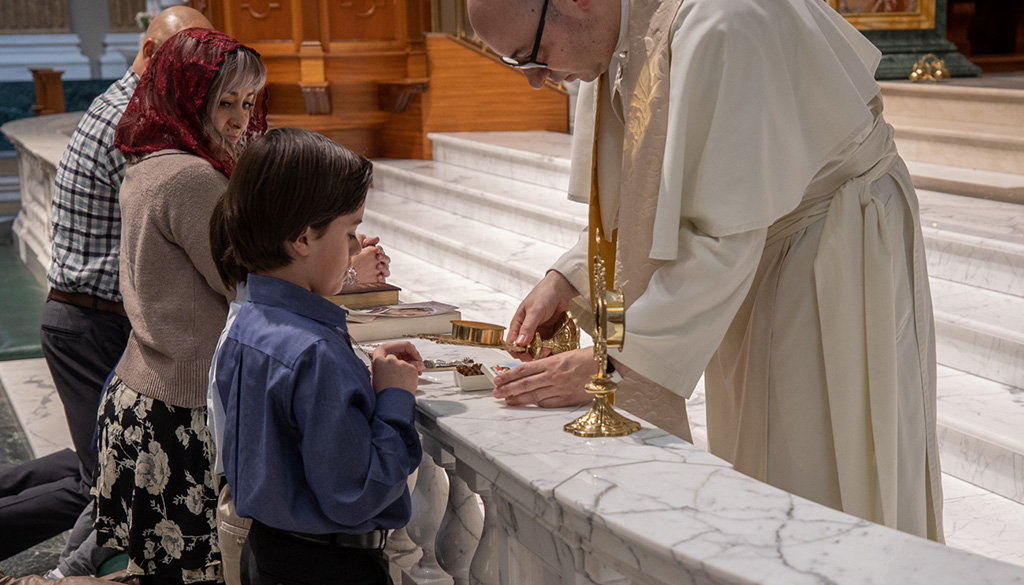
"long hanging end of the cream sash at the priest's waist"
814,138,899,526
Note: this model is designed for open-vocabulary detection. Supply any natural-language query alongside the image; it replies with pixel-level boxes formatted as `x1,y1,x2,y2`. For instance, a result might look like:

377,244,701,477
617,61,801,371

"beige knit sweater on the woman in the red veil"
116,151,233,408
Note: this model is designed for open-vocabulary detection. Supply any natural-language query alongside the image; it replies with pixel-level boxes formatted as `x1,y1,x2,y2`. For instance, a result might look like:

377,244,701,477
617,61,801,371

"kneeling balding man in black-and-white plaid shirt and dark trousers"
0,6,213,575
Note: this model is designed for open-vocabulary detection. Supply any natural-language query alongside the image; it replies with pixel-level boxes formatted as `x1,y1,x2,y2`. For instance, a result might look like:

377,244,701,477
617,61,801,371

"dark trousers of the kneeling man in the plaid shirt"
0,299,131,558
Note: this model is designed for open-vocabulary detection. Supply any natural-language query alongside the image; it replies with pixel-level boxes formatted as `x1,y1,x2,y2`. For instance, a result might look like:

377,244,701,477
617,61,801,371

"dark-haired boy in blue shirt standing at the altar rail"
211,128,423,584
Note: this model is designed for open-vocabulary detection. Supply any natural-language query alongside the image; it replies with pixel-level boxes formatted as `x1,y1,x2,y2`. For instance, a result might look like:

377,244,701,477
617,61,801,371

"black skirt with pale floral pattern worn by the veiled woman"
94,376,222,583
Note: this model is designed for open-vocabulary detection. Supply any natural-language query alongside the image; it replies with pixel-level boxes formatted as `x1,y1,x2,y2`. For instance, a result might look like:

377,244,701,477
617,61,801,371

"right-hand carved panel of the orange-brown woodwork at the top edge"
327,0,404,42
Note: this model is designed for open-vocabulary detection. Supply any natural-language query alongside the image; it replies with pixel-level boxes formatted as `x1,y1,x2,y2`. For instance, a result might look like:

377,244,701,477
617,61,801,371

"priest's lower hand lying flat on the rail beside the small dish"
495,347,597,408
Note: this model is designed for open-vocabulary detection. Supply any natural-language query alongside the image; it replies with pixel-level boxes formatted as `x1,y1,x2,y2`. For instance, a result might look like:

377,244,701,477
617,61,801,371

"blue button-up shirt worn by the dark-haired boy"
216,275,422,534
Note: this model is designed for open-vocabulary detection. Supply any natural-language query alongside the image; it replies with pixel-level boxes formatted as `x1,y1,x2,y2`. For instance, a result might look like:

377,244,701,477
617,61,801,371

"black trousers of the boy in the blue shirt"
242,520,393,585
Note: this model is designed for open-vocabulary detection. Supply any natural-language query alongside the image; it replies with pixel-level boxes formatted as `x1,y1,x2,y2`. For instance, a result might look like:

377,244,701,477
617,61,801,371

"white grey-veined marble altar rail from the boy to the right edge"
393,341,1024,585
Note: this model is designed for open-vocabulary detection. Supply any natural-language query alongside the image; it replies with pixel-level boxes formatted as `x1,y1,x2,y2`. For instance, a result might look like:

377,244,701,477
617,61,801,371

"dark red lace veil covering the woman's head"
114,29,266,176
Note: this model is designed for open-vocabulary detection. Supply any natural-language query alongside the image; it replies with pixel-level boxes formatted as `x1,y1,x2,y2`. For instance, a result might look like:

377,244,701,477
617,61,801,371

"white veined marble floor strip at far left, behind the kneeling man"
0,358,75,457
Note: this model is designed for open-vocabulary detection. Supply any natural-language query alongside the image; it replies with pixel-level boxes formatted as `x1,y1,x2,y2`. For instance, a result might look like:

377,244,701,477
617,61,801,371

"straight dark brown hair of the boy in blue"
210,128,373,287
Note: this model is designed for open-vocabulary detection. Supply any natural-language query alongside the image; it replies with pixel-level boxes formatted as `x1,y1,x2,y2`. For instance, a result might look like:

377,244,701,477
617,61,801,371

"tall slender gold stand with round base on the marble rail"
562,229,640,436
